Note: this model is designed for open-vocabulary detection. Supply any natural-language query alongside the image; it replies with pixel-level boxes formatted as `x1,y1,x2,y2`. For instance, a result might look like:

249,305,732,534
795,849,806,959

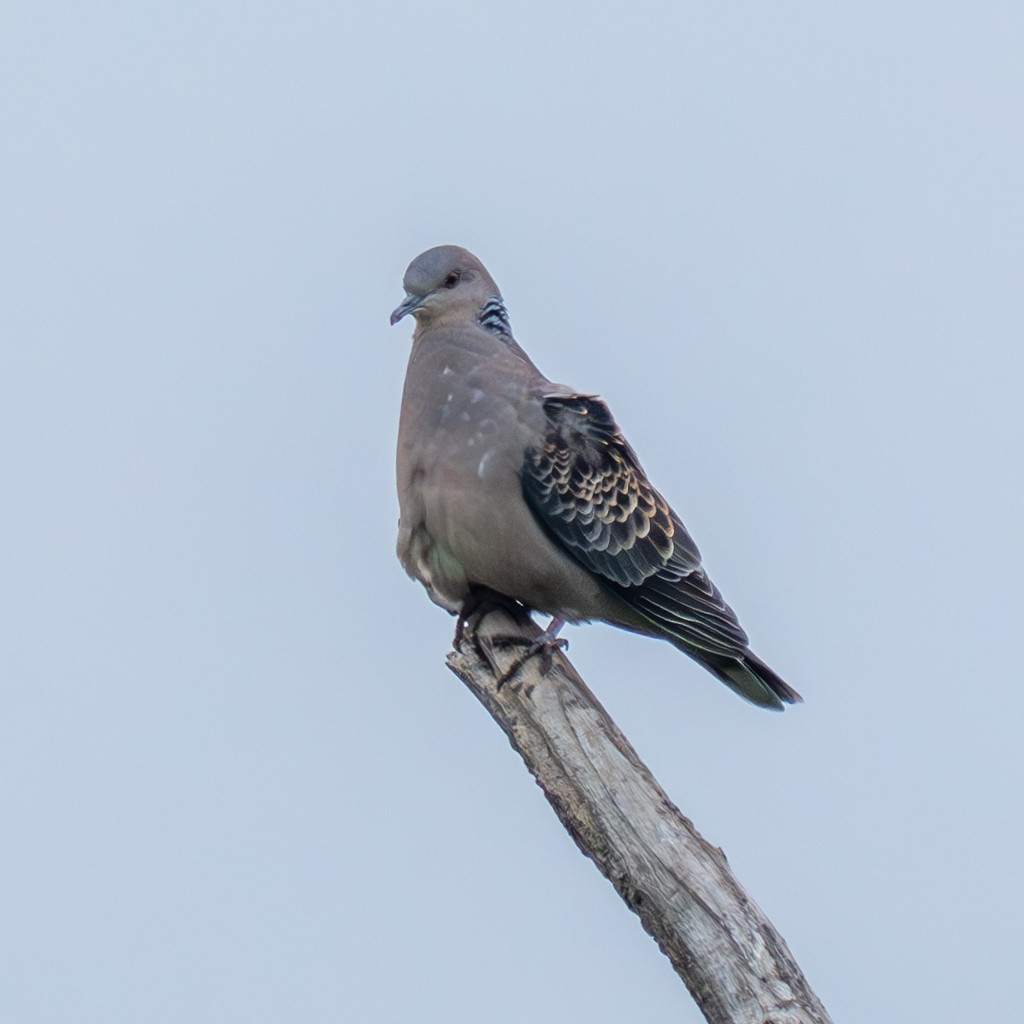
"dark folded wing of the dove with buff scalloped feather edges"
521,393,746,656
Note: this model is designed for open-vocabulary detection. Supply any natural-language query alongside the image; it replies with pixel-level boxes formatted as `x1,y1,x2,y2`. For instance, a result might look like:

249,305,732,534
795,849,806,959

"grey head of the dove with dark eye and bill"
391,246,501,325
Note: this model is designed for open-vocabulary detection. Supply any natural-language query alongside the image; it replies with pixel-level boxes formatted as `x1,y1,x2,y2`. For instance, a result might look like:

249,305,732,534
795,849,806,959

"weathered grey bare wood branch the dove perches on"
449,611,830,1024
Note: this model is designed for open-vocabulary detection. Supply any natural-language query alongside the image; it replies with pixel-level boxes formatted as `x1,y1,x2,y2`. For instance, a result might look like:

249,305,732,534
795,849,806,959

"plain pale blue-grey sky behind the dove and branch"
0,0,1024,1024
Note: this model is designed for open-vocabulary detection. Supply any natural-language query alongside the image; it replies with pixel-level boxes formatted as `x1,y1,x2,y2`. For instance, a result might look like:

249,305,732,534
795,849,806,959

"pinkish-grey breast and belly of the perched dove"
398,339,611,620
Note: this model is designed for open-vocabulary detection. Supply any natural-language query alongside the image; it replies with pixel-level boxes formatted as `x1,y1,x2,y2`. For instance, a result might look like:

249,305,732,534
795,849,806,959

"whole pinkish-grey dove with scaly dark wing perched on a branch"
390,245,802,711
